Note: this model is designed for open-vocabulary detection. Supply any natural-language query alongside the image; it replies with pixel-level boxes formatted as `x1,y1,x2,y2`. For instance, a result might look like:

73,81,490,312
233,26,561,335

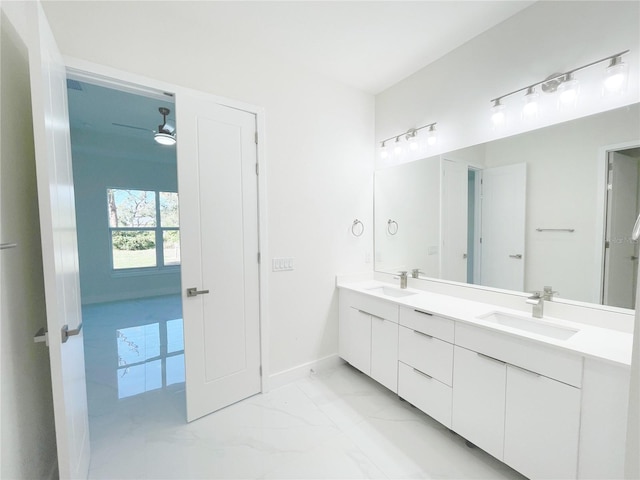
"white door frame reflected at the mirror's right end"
592,139,640,307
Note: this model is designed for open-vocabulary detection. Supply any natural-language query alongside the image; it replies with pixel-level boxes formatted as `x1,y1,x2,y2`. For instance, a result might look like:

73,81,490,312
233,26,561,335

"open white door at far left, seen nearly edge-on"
28,2,89,479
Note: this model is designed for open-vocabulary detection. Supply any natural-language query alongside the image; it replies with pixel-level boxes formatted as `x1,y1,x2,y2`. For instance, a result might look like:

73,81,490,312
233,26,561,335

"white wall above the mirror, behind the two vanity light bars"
376,1,640,164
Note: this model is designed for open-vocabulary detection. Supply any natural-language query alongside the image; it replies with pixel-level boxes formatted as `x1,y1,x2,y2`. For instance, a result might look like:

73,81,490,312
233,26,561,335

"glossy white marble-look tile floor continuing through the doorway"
85,299,524,480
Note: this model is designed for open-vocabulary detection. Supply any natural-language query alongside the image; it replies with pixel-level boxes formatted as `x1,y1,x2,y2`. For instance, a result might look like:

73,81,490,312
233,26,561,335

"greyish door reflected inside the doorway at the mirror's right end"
603,152,638,308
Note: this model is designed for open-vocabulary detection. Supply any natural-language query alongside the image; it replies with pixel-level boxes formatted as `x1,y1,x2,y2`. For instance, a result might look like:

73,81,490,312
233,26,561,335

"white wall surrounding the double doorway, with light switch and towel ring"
44,2,374,374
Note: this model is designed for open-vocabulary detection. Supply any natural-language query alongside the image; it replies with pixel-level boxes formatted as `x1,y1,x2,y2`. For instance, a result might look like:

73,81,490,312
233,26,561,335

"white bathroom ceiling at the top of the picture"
44,0,535,94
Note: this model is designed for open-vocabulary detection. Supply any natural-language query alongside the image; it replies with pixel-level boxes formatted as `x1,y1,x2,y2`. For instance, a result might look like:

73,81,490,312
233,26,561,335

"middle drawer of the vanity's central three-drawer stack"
398,326,453,386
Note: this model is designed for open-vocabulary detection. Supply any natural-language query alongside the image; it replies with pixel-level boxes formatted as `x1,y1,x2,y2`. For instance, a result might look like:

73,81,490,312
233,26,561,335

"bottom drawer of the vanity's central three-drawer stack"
398,362,451,428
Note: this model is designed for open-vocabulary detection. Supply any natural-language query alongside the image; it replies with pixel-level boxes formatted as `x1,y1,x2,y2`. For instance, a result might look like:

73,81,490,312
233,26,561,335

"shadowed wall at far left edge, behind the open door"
0,2,56,479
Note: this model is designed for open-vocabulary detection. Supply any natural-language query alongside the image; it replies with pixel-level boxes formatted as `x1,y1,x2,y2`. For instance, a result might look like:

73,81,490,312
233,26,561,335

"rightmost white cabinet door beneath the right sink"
504,365,580,479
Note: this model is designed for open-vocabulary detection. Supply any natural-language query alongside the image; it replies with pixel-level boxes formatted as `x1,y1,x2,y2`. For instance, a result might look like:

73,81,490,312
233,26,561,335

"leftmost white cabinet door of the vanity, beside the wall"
340,307,371,375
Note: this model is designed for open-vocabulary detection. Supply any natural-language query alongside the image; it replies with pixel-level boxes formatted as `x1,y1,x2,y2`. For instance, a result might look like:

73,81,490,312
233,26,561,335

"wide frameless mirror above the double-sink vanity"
375,104,640,308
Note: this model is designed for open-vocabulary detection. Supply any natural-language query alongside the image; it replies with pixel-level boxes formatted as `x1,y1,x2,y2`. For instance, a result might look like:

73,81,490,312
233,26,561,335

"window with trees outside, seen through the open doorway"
107,188,180,270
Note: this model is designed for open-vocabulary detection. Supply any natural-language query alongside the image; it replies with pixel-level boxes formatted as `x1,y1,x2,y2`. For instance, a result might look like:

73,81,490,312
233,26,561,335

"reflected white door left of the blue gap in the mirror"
441,160,469,282
